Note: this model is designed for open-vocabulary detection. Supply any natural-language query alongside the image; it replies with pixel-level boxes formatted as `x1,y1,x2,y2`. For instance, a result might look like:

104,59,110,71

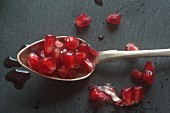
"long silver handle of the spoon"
97,49,170,63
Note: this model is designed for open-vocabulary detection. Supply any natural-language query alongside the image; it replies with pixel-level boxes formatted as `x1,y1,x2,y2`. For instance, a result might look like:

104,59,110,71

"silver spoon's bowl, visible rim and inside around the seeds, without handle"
17,36,94,81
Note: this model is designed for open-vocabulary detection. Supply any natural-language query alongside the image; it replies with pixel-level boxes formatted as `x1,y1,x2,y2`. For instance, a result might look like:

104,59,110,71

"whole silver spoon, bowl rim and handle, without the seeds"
17,36,170,81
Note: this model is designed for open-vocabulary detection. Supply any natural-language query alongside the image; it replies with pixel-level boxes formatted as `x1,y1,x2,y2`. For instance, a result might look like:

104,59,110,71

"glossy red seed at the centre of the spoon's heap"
61,51,77,68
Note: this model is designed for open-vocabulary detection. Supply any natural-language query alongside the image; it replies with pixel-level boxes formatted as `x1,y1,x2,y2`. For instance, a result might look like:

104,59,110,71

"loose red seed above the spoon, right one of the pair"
106,12,122,25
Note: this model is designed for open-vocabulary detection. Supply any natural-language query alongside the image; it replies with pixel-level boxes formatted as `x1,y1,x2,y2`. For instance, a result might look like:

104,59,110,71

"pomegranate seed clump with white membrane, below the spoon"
89,85,144,106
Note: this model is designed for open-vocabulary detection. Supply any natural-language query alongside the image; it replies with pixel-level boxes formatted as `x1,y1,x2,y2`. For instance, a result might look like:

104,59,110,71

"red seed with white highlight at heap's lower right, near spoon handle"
80,59,94,73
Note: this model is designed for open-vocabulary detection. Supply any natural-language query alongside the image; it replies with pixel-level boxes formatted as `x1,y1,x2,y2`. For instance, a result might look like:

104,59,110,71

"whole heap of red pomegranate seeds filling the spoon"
27,34,98,79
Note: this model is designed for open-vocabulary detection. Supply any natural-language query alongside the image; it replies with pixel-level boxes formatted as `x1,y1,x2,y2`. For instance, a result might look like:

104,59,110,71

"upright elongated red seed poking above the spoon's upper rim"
44,34,56,53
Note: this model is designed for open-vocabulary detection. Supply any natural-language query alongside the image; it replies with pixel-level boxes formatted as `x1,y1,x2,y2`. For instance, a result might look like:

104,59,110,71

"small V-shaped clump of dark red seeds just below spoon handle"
131,61,156,85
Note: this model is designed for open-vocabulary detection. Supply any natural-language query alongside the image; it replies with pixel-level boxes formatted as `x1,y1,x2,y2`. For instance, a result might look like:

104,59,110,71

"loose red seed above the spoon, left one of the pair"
75,13,91,27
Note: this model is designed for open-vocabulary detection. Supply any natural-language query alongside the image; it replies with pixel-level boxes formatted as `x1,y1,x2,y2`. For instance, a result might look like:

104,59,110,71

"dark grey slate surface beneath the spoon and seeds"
0,0,170,113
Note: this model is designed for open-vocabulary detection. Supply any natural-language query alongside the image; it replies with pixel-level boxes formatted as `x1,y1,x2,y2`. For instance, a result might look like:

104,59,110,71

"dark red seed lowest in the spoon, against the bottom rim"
58,66,77,79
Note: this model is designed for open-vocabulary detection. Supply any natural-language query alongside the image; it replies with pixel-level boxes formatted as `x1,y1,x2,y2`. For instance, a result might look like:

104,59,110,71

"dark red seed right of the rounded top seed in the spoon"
78,42,89,58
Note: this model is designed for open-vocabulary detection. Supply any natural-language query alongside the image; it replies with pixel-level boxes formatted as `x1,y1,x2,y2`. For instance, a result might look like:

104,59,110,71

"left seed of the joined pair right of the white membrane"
121,87,134,106
